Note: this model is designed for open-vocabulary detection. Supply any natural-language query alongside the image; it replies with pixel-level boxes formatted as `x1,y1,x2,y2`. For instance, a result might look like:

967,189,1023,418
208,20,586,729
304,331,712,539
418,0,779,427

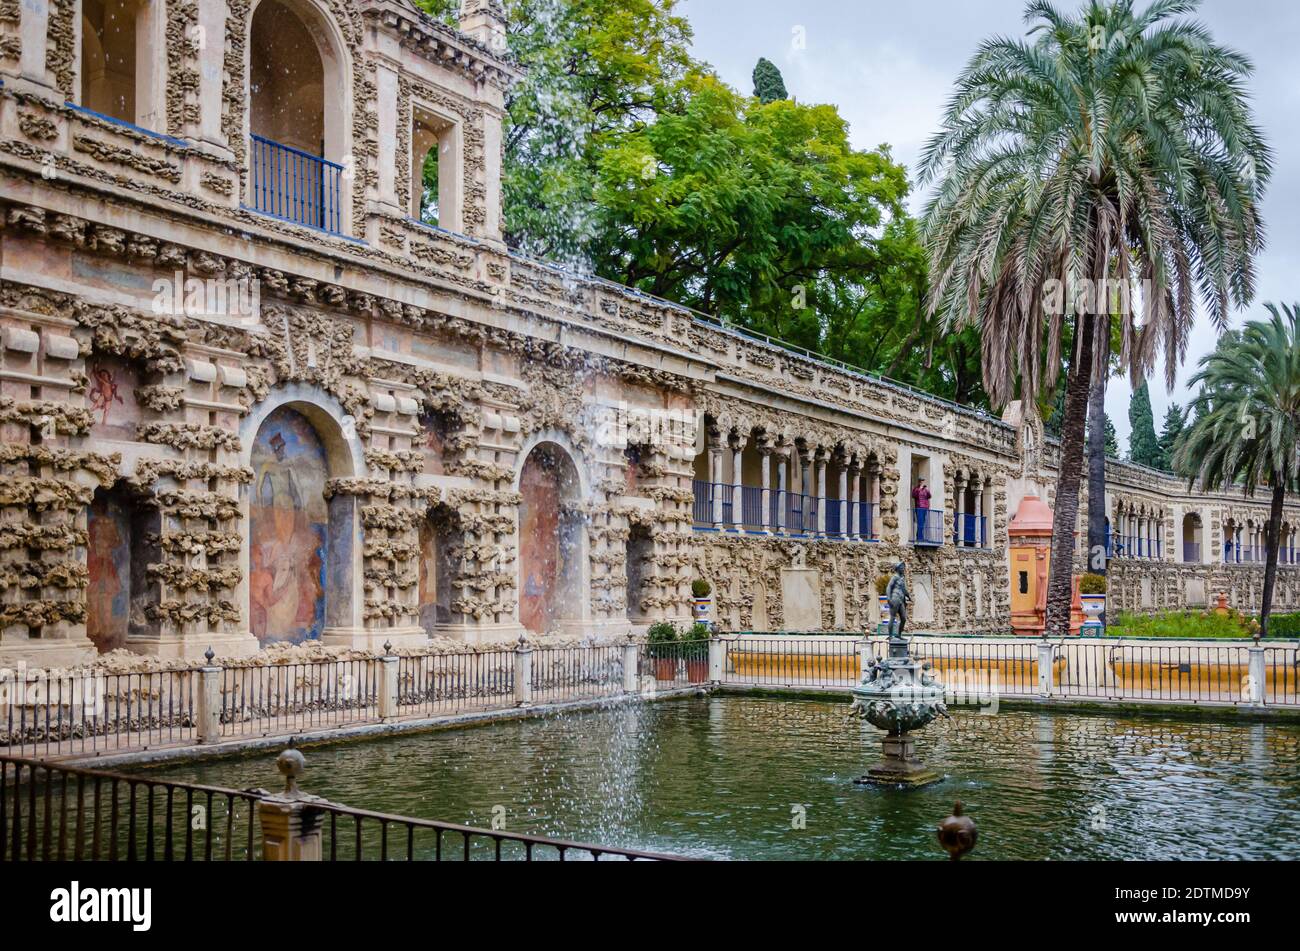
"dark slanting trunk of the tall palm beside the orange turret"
1047,313,1095,637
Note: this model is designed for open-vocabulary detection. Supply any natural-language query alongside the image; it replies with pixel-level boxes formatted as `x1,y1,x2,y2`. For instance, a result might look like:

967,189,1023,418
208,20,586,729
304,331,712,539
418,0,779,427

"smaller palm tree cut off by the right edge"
1174,304,1300,637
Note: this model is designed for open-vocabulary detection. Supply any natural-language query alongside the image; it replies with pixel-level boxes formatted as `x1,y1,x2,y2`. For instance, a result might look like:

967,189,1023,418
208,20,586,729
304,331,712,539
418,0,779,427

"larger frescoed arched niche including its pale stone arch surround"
241,386,364,646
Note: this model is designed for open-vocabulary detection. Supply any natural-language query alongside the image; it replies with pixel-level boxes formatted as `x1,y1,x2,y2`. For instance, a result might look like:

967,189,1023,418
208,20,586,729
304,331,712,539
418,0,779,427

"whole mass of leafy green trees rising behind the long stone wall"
421,0,987,405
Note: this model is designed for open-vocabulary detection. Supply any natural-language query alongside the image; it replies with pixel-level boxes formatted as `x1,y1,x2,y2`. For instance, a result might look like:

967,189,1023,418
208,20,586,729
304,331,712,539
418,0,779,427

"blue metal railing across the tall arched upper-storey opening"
248,135,343,234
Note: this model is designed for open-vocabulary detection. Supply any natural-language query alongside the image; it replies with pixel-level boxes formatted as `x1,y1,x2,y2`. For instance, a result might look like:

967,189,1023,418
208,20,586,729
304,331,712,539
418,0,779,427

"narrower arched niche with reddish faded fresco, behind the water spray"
519,443,586,634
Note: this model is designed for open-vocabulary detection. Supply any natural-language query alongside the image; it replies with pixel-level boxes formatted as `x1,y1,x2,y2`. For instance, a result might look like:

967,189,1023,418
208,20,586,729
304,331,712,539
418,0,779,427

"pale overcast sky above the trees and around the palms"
680,0,1300,451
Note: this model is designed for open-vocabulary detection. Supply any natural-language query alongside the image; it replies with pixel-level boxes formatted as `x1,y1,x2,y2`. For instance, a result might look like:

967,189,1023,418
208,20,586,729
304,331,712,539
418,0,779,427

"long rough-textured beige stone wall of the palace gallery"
0,0,1300,664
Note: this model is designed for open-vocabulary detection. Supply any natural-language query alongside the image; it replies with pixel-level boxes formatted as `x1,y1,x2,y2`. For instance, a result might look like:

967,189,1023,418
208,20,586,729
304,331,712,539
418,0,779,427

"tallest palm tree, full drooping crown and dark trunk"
920,0,1271,634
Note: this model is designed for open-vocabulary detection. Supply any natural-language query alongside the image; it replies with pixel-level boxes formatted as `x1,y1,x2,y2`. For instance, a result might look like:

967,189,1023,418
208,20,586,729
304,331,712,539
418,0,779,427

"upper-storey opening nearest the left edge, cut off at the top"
79,0,163,131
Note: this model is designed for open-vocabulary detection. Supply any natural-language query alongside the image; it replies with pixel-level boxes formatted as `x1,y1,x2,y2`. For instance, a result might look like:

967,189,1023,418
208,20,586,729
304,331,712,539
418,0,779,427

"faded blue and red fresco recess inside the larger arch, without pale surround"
248,407,355,644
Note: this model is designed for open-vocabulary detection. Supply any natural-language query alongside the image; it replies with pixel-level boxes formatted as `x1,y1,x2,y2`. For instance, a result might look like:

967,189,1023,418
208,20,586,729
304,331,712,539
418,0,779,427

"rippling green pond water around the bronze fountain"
142,696,1300,859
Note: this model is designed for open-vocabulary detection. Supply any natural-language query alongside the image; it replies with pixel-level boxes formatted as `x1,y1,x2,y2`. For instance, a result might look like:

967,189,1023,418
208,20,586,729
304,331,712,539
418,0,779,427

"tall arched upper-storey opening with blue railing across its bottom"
247,0,348,231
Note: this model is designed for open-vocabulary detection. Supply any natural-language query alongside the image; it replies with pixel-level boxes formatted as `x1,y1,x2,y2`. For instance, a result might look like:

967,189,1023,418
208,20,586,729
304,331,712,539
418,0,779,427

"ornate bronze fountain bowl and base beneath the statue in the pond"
850,637,948,786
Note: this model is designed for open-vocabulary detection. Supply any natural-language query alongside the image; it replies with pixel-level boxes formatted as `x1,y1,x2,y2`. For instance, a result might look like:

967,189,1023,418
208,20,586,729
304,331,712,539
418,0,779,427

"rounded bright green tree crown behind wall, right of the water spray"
595,75,926,355
